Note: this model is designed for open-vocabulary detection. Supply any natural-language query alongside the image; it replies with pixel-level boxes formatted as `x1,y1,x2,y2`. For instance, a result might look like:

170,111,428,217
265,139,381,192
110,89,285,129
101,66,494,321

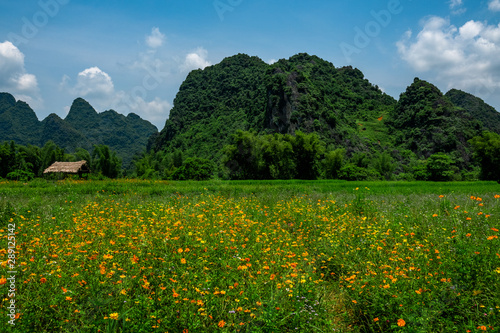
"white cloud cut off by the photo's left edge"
0,41,43,108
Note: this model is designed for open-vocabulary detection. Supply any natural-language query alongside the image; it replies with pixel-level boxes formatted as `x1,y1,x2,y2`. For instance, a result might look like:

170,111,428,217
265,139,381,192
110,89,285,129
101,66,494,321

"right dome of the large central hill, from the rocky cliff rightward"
265,53,396,149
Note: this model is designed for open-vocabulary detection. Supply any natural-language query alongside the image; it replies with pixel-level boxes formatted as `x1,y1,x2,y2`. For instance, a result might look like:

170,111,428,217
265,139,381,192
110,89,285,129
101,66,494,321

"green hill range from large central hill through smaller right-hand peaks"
152,53,500,170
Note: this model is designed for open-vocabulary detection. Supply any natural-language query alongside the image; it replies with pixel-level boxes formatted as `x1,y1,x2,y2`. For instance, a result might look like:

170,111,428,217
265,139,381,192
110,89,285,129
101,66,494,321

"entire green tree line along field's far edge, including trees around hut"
0,130,500,181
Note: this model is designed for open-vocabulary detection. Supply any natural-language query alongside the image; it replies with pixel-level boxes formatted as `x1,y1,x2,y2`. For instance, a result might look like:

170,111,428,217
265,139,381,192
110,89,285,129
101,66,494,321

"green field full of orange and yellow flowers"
0,180,500,332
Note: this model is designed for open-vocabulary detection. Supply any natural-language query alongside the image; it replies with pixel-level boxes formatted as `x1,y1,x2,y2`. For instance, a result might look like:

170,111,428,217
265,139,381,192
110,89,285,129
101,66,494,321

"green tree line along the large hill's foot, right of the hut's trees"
133,130,500,181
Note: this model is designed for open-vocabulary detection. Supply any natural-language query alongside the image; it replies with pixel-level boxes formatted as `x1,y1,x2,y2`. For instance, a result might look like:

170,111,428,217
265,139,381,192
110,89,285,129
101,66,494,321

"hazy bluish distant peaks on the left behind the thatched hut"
0,93,158,166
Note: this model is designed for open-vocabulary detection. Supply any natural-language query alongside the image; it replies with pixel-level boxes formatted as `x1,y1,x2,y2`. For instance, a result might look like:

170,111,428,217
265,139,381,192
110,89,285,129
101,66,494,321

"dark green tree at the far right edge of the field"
469,132,500,182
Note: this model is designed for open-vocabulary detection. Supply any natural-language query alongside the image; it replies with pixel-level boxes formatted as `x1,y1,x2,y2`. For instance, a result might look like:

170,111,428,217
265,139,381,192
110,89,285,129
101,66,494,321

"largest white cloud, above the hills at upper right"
397,17,500,100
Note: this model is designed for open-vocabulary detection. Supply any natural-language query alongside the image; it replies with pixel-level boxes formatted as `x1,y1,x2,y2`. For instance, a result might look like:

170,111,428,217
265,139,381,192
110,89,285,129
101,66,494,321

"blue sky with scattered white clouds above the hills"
0,0,500,130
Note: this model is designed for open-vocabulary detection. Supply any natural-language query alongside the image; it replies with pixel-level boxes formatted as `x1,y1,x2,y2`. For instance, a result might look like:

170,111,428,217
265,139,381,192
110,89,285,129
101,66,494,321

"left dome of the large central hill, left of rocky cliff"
154,54,268,158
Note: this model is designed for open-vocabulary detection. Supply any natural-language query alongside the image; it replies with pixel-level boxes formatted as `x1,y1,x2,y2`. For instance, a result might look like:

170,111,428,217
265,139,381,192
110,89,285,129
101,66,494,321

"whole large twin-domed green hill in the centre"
154,53,396,159
